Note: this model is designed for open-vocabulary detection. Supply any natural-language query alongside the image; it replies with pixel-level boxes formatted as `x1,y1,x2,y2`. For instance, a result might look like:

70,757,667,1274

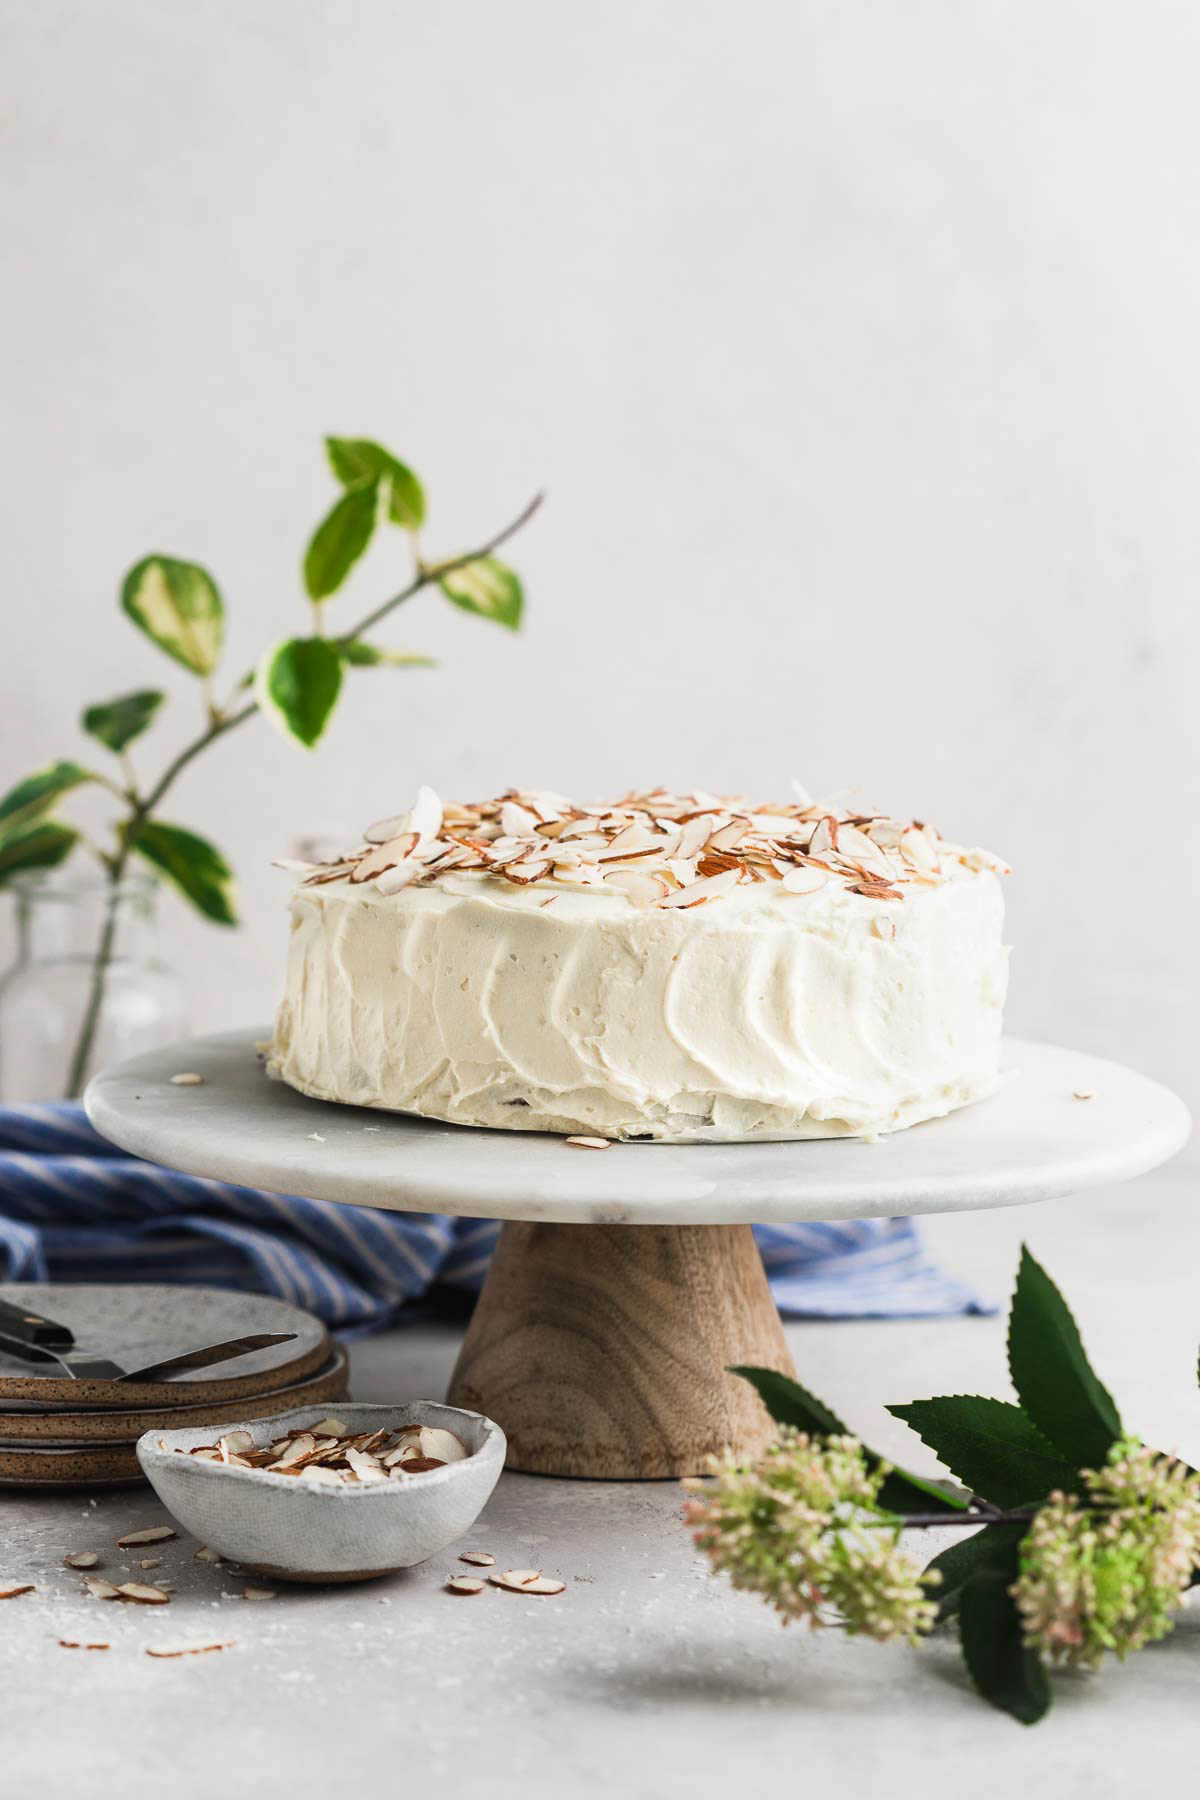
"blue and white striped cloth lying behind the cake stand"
0,1103,991,1330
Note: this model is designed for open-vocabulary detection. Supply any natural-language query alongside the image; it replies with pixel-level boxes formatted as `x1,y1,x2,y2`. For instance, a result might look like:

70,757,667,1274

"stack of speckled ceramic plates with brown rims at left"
0,1283,349,1487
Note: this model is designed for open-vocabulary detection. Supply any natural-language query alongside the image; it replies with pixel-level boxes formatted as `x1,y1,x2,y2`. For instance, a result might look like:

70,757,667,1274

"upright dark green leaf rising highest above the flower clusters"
1007,1244,1121,1469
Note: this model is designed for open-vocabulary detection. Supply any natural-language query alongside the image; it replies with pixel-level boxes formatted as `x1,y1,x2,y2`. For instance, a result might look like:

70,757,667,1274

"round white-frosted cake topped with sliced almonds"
272,796,1007,1139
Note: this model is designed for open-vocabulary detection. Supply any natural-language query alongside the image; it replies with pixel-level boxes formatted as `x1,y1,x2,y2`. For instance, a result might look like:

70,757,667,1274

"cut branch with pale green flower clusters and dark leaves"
684,1251,1200,1724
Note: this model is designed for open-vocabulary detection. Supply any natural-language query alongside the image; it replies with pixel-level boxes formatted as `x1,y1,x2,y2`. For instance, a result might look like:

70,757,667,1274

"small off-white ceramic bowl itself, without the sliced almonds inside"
137,1400,507,1580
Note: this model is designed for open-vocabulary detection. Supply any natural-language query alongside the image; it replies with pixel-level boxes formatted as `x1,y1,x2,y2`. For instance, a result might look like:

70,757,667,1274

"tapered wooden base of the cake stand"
448,1222,792,1480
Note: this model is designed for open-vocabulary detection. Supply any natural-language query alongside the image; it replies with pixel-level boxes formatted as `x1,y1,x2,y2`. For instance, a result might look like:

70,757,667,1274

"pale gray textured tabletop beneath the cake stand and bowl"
0,1170,1200,1800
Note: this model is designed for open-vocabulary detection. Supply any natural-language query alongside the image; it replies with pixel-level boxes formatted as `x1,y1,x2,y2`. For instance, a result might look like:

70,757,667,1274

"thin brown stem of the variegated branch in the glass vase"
65,493,545,1100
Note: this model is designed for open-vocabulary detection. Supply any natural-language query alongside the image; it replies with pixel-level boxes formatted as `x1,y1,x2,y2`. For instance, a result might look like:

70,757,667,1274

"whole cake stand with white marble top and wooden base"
85,1031,1189,1480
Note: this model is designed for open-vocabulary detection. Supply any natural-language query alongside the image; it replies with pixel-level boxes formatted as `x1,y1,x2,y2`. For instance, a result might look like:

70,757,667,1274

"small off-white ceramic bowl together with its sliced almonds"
137,1400,507,1582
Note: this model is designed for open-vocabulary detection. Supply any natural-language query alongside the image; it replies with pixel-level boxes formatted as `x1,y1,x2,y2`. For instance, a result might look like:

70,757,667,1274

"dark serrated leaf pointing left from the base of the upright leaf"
887,1393,1079,1507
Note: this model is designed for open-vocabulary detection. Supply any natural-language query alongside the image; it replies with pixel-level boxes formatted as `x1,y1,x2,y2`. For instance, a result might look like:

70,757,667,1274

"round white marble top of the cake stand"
86,1030,1187,1224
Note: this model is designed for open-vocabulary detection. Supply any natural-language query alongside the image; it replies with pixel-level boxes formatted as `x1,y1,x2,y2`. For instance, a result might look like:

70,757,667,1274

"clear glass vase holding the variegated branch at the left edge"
0,873,185,1105
